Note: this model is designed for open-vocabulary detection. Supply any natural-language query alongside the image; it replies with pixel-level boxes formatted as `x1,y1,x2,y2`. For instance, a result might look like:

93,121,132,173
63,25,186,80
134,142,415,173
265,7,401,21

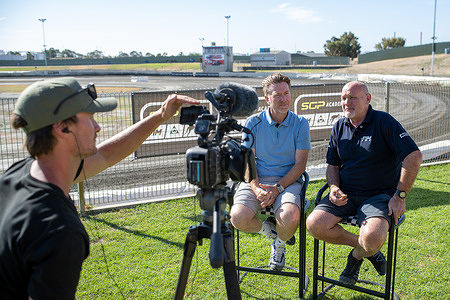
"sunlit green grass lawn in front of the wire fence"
77,164,450,299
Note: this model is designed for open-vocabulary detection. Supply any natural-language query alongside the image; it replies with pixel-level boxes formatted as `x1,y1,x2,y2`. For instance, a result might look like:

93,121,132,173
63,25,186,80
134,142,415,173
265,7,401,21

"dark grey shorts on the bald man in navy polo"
315,194,392,226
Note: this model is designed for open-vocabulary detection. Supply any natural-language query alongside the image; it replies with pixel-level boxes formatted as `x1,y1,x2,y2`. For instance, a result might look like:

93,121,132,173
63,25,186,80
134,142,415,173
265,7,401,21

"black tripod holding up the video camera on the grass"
174,187,241,300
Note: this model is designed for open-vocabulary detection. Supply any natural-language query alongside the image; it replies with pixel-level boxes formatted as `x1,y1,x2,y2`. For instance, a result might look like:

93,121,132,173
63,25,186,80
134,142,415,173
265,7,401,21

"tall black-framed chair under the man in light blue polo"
235,171,309,298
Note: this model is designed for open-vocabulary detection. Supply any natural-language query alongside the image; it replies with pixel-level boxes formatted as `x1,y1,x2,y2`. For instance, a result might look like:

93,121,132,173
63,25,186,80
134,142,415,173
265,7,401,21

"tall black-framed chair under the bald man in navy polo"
313,184,405,299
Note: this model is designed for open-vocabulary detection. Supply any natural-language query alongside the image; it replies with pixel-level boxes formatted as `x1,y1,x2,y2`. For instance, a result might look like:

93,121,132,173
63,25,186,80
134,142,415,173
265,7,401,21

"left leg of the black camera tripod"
173,226,198,300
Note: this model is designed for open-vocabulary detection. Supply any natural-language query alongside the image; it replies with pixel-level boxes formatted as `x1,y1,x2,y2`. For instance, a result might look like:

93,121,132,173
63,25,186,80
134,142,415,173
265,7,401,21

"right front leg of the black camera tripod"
223,229,241,300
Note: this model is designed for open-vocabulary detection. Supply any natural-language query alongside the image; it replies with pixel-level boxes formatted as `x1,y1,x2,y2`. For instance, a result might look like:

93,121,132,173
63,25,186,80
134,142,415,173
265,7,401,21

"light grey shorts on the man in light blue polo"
233,176,303,214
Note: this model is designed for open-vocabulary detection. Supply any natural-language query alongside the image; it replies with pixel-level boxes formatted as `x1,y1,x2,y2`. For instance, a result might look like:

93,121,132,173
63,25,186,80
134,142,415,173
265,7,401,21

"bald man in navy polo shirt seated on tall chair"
306,81,422,284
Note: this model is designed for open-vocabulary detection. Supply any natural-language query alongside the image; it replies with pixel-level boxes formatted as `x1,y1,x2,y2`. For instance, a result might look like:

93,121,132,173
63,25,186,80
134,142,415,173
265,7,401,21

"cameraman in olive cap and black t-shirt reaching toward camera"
0,78,199,299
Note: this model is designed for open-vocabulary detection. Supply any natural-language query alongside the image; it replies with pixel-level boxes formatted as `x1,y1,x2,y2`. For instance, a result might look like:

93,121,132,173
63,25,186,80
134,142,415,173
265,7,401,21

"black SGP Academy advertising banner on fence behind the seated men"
132,84,343,158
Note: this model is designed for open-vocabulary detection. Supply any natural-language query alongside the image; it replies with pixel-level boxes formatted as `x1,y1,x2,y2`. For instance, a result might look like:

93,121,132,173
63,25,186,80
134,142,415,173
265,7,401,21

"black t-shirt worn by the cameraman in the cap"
0,158,89,300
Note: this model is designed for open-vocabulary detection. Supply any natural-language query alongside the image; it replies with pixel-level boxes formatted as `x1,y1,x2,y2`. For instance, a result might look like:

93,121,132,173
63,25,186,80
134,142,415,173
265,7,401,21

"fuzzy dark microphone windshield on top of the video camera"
215,82,259,117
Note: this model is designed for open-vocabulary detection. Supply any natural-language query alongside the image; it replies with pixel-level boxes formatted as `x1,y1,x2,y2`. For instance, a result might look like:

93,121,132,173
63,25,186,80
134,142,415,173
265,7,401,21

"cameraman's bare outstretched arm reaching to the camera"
77,94,200,182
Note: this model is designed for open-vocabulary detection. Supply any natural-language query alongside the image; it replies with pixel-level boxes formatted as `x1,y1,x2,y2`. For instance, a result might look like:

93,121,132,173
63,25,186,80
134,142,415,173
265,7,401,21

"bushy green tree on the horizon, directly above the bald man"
323,32,361,58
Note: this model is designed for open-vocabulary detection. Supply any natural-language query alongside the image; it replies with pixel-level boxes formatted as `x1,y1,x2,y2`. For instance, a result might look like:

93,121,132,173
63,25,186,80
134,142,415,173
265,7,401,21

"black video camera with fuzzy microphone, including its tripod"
175,82,259,278
